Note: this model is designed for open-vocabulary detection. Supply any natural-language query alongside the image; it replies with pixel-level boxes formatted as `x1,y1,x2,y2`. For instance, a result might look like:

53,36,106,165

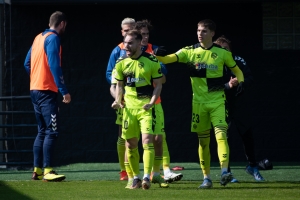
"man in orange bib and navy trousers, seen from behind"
24,11,71,181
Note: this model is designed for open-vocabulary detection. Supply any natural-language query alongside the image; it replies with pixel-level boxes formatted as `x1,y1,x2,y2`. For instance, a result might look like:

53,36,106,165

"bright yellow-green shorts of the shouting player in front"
122,107,153,140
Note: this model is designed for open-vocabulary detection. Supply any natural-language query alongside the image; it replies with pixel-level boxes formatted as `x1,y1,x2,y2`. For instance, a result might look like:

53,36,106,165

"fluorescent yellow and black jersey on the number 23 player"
176,43,236,103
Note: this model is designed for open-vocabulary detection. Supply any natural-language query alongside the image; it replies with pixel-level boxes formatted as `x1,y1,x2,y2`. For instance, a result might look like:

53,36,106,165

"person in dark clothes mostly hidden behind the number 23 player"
215,36,264,182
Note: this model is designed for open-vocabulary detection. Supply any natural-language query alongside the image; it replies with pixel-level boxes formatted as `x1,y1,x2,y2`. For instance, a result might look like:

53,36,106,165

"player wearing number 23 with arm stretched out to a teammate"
156,19,244,188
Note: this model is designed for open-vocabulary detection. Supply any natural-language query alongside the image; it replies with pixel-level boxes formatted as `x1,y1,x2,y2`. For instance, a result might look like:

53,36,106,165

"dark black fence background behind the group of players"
2,1,300,165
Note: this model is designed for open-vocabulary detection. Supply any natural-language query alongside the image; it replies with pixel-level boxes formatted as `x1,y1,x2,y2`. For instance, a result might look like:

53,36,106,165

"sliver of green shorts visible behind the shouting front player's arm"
152,103,165,136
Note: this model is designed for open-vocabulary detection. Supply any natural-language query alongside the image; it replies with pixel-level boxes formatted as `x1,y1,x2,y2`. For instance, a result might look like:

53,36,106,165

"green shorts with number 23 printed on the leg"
191,101,227,133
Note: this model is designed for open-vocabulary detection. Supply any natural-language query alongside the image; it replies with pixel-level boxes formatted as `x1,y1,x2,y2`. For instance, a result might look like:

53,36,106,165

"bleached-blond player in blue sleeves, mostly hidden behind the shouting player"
106,17,135,181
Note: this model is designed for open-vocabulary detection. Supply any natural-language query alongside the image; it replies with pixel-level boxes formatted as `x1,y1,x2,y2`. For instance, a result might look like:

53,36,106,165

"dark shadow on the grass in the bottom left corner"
0,181,32,200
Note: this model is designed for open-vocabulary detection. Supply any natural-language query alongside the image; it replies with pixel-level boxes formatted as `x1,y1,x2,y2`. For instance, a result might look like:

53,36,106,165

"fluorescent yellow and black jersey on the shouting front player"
114,52,162,109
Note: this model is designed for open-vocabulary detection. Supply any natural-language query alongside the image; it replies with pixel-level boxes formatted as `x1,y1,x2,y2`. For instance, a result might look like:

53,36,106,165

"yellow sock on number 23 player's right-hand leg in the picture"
215,126,229,171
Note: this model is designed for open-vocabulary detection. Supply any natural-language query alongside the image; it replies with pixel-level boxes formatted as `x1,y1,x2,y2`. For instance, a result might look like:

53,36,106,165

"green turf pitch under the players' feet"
0,163,300,200
